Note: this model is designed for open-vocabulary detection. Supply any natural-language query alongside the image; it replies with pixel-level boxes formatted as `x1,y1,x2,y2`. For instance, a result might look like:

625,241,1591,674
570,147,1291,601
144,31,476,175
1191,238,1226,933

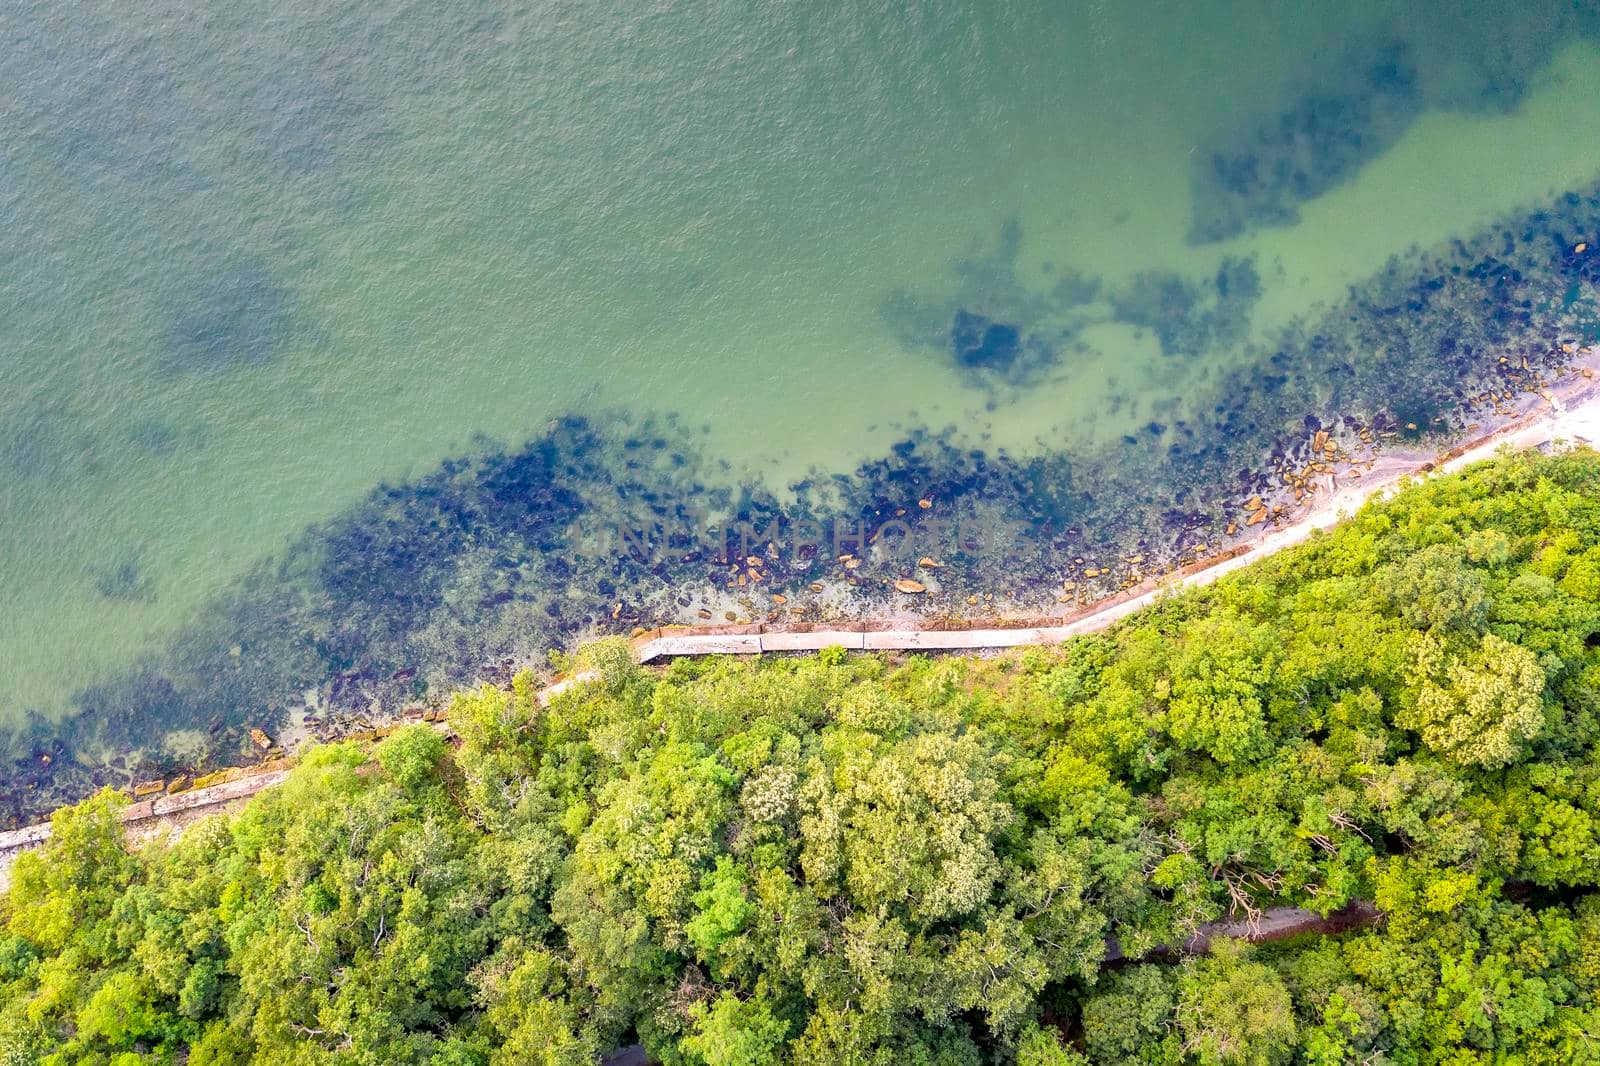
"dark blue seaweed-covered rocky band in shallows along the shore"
5,172,1600,820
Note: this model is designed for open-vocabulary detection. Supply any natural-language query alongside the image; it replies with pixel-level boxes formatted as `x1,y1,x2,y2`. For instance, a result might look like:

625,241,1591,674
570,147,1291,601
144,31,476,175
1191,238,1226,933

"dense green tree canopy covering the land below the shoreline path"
9,451,1600,1066
